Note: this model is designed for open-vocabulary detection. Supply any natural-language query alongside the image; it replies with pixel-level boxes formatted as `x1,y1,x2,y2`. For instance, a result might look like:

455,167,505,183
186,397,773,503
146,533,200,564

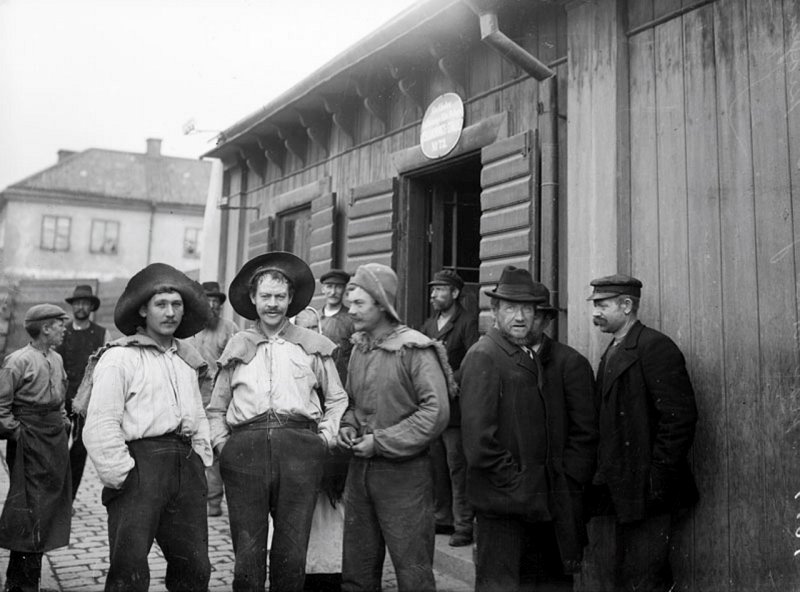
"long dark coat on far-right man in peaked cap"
595,322,698,523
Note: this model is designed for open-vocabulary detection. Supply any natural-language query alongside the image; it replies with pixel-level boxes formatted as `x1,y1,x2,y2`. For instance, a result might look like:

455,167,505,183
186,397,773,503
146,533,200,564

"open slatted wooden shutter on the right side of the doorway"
480,132,538,330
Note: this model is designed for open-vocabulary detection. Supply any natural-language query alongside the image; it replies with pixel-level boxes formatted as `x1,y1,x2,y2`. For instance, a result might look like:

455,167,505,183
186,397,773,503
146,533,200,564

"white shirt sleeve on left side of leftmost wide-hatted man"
83,359,136,489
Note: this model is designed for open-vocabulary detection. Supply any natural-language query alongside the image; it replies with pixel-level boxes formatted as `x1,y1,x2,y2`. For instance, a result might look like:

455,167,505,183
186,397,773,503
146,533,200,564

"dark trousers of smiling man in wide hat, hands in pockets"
219,424,327,592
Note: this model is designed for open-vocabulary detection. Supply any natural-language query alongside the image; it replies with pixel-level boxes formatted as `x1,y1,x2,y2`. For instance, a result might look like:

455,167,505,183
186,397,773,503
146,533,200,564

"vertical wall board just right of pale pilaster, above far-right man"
629,30,661,327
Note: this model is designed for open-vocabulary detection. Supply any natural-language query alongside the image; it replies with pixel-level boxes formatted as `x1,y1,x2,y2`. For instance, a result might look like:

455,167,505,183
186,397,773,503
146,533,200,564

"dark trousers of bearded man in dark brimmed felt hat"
475,513,572,592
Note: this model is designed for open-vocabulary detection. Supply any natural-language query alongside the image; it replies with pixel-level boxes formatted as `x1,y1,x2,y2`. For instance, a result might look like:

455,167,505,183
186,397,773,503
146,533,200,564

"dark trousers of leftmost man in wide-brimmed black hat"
103,436,211,592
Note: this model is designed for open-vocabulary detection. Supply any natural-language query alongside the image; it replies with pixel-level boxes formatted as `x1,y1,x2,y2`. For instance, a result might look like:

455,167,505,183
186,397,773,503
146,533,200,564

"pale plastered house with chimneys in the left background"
0,139,211,351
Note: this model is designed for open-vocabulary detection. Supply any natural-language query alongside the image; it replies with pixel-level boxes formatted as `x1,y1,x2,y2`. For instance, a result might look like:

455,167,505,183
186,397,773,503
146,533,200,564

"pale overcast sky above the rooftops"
0,0,416,189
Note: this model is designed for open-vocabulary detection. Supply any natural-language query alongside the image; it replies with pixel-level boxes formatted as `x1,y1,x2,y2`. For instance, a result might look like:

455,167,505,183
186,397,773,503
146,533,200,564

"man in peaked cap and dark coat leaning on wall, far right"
588,274,698,592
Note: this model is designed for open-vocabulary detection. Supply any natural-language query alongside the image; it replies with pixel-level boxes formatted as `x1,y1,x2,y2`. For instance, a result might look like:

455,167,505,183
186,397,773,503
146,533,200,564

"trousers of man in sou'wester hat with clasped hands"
342,455,436,592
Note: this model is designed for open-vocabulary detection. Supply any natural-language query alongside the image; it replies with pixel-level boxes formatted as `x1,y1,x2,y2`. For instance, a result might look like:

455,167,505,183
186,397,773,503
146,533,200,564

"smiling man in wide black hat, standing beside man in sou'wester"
208,252,347,592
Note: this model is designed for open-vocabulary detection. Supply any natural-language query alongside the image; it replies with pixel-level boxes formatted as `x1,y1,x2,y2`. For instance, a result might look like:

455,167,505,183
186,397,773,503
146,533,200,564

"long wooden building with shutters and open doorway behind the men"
208,0,800,592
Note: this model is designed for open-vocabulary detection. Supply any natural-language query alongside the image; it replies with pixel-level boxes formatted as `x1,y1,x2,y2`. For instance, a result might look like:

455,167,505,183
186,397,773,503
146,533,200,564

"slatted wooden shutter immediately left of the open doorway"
347,179,397,270
